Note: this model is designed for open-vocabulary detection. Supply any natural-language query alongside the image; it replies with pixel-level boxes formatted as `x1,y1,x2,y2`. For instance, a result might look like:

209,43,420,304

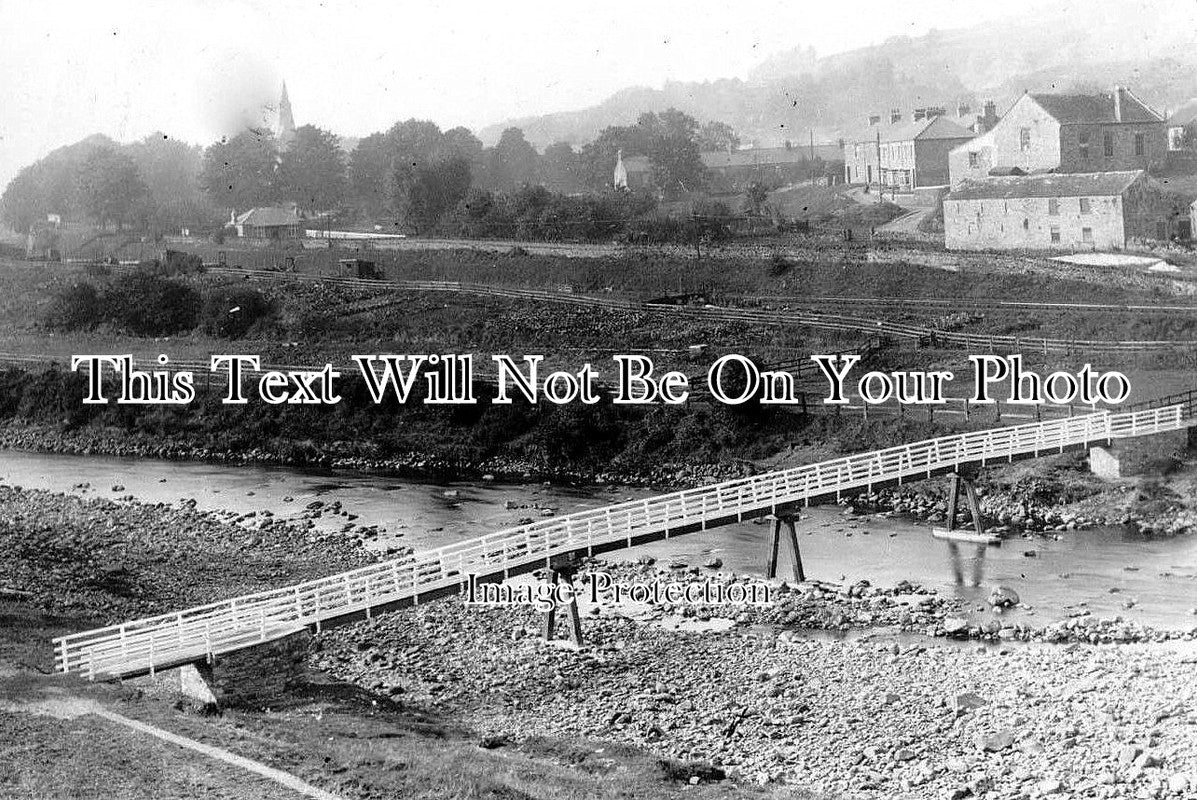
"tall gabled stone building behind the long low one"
948,86,1167,186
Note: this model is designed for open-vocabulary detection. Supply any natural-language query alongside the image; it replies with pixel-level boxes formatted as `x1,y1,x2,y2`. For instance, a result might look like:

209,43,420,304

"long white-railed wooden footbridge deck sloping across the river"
54,393,1197,678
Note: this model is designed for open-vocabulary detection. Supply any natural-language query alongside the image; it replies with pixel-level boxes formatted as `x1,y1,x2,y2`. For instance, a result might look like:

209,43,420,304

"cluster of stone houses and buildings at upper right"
844,86,1197,250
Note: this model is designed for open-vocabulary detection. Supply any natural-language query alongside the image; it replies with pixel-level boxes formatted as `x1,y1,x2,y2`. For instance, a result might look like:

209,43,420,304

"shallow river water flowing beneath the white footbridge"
0,450,1197,629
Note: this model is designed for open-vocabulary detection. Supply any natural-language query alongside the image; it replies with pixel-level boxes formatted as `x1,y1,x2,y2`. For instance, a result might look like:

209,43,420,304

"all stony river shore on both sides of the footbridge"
0,486,1197,800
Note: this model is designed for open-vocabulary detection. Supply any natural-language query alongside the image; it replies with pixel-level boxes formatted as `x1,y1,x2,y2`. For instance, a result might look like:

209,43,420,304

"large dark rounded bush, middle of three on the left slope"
104,272,200,337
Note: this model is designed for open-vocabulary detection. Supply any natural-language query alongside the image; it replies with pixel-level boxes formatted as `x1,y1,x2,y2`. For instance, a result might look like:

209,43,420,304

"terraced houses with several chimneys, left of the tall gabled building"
844,109,973,192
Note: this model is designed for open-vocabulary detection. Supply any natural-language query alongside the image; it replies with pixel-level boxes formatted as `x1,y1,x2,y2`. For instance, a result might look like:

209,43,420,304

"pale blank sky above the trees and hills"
0,0,1086,187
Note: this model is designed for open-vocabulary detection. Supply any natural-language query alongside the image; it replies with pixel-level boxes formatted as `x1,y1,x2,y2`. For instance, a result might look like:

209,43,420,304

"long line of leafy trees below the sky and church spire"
0,109,739,237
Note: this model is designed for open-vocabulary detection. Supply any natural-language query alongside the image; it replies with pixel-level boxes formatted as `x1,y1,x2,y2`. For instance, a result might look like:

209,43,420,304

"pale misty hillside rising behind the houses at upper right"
480,4,1197,147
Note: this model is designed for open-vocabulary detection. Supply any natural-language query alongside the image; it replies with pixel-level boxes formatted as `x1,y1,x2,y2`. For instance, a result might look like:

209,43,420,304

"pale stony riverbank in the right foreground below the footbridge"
312,565,1197,800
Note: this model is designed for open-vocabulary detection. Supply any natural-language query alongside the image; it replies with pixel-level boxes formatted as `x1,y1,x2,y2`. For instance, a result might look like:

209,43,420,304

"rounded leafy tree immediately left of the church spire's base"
200,131,280,208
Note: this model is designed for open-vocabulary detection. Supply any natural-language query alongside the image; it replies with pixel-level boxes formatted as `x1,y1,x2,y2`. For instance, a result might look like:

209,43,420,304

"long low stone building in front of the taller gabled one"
943,170,1187,250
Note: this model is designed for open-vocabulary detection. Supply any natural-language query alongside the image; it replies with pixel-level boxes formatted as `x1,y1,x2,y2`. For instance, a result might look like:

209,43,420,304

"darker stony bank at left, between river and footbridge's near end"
0,485,378,622
